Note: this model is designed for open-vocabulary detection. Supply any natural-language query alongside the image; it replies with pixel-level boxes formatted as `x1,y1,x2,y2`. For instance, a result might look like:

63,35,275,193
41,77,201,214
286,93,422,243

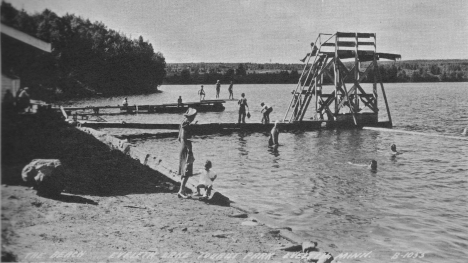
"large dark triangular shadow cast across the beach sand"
2,115,177,198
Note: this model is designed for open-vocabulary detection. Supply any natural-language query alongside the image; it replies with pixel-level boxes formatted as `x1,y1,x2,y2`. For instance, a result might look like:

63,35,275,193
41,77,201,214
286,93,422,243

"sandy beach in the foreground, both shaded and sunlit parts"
1,115,292,262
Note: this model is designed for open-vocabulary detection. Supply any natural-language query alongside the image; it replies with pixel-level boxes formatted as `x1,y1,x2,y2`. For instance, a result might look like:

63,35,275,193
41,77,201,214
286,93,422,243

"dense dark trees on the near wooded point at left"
1,1,166,99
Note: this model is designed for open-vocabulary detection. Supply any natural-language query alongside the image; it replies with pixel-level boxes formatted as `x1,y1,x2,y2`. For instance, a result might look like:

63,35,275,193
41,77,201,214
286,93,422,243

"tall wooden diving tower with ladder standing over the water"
283,32,401,126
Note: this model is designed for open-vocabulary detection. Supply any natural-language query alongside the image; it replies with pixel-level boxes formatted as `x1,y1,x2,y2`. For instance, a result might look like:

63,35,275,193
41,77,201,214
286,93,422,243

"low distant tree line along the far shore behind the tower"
165,60,468,84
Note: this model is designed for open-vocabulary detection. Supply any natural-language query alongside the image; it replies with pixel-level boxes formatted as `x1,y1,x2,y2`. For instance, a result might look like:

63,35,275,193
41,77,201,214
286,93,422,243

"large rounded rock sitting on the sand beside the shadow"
21,159,66,196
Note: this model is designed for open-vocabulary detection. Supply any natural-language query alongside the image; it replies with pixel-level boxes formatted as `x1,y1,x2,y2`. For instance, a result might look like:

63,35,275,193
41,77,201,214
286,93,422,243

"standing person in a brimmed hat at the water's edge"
177,108,197,198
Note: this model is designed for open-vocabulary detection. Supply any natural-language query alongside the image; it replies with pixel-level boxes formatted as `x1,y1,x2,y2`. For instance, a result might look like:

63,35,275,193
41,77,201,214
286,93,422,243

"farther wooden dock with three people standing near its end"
56,100,226,116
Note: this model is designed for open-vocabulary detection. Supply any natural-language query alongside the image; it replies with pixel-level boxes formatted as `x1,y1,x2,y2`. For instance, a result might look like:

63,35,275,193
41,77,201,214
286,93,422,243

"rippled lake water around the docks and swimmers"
63,83,468,262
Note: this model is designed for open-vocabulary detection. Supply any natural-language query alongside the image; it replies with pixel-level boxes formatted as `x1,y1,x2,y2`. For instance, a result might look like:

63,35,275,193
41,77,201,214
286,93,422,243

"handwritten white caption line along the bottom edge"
22,250,431,263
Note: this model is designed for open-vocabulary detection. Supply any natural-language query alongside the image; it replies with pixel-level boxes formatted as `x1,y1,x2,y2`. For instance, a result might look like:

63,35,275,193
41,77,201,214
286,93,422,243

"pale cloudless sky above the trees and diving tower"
6,0,468,63
